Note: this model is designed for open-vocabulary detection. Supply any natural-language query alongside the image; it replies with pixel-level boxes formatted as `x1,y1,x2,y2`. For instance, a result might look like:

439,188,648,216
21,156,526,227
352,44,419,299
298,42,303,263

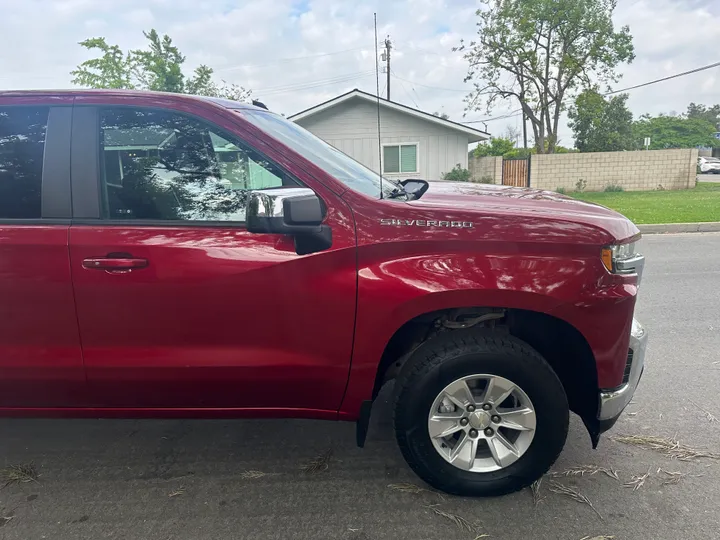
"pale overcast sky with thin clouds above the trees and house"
0,0,720,145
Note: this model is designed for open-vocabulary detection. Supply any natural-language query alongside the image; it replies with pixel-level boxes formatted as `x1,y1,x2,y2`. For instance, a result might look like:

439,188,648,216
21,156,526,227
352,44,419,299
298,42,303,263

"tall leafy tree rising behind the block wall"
456,0,635,153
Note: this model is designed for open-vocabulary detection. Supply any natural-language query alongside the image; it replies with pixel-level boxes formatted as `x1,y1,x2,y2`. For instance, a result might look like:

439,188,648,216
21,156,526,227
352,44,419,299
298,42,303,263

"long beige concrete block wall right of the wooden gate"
530,149,698,191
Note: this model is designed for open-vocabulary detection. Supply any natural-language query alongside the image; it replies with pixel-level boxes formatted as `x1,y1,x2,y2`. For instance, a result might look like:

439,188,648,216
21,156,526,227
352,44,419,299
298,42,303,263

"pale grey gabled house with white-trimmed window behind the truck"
288,89,490,180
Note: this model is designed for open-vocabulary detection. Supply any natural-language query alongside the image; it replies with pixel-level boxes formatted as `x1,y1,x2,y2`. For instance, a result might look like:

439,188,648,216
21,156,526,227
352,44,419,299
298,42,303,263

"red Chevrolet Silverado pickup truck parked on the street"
0,91,647,495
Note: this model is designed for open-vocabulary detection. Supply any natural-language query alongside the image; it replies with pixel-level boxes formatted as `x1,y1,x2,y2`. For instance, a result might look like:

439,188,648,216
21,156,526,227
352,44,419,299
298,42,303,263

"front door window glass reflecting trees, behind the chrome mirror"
100,107,294,221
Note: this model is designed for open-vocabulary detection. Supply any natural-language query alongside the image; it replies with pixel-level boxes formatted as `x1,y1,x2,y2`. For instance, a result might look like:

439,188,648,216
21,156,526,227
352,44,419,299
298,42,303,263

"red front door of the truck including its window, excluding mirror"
70,98,356,411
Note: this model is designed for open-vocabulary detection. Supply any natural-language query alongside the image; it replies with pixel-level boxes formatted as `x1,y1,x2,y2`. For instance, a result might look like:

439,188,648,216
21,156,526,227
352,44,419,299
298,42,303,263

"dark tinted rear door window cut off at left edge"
0,107,49,219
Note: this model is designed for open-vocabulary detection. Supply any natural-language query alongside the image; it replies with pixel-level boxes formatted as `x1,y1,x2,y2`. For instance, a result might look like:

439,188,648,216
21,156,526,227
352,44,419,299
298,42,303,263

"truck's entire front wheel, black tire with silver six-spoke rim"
395,328,569,496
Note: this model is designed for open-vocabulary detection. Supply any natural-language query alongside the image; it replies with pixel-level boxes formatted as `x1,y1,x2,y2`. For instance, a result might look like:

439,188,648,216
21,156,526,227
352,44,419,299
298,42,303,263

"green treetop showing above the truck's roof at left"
70,29,251,101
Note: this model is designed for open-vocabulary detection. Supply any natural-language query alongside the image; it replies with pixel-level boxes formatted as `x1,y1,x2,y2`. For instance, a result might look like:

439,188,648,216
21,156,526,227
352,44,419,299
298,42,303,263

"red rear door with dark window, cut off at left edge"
0,100,86,408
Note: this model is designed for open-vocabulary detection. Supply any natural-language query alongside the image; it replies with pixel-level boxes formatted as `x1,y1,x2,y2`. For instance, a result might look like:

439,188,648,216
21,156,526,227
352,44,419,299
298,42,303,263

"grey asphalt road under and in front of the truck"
0,233,720,540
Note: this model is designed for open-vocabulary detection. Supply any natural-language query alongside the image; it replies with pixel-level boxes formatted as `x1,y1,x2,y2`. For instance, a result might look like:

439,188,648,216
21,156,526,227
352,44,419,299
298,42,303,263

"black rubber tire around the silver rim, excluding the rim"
394,328,569,496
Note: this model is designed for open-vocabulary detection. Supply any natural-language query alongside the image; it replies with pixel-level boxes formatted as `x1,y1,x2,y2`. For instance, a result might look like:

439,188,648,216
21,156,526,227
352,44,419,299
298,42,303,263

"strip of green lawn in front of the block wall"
569,182,720,223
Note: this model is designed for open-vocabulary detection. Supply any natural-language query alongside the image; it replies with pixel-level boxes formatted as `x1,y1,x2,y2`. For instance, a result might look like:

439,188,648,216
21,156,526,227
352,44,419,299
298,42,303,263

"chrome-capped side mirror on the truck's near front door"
245,188,332,255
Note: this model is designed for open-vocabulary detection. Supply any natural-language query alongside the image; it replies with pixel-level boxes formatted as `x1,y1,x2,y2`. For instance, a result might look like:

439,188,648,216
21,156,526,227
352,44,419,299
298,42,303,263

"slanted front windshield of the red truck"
235,109,403,198
